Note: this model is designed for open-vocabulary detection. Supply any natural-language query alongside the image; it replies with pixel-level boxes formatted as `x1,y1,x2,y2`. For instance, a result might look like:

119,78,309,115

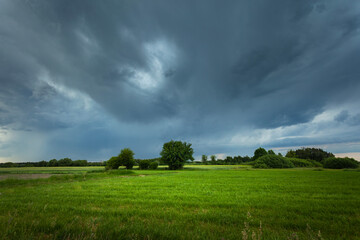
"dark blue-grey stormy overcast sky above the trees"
0,0,360,162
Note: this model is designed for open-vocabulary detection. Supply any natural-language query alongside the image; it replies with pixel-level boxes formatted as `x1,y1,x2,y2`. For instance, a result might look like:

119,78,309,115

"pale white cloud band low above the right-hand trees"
230,108,360,155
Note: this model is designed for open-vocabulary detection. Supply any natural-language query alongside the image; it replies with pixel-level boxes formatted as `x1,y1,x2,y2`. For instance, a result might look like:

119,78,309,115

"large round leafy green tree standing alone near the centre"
160,140,194,170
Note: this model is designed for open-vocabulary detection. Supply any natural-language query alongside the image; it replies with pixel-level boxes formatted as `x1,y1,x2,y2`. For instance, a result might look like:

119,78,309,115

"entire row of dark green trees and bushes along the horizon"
0,140,358,170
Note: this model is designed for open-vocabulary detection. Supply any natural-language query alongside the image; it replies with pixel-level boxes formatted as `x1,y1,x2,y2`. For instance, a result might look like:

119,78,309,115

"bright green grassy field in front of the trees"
0,166,360,239
